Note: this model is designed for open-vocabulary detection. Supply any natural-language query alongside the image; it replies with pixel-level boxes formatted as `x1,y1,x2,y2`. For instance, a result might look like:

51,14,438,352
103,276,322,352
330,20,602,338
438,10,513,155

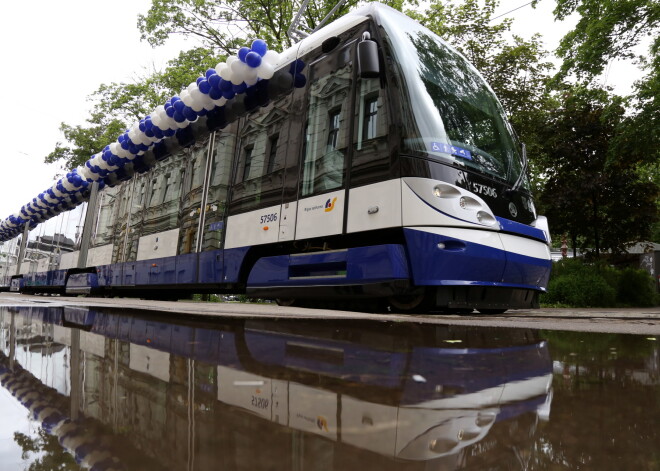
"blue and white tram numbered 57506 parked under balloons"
3,3,551,313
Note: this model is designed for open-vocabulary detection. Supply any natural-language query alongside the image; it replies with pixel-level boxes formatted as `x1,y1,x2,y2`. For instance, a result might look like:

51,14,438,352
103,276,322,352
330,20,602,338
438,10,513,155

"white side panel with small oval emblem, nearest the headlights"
347,179,401,232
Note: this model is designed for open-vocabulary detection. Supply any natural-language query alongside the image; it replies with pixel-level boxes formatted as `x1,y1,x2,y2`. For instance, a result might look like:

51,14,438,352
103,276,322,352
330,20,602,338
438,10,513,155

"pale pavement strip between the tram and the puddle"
0,293,660,337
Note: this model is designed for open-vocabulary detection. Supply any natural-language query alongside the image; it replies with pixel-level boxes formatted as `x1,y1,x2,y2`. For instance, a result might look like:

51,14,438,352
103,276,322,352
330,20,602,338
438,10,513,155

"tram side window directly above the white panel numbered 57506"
230,96,291,214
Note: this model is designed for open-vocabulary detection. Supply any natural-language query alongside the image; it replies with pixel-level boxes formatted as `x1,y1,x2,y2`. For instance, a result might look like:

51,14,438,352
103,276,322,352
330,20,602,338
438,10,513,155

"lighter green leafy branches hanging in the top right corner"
540,0,660,242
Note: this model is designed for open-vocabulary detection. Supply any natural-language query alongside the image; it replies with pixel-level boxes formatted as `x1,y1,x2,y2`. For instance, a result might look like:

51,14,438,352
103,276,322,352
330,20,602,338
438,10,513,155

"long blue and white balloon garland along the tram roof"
0,39,306,242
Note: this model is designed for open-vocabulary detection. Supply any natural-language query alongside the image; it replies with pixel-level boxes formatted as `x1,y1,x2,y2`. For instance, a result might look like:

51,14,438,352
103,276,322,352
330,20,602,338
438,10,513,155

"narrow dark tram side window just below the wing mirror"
351,78,391,186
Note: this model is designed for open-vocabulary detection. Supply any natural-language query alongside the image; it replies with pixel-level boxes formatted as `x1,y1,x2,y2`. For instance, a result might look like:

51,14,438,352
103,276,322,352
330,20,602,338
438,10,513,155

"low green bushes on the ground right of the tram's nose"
541,259,657,307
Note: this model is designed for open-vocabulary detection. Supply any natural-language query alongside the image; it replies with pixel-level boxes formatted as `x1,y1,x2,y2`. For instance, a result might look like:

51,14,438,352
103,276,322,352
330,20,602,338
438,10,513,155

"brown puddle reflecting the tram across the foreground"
0,306,660,471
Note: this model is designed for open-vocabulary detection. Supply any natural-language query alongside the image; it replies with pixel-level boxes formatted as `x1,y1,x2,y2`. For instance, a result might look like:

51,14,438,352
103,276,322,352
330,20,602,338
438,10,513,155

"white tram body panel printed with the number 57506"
225,205,282,253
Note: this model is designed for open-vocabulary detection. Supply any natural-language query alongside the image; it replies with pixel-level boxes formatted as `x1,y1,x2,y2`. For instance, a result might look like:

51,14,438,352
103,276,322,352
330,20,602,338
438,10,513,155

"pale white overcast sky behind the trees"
0,0,639,232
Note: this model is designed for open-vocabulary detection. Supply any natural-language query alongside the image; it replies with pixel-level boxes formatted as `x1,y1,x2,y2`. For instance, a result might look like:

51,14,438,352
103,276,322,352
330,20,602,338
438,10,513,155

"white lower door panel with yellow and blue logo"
296,190,345,240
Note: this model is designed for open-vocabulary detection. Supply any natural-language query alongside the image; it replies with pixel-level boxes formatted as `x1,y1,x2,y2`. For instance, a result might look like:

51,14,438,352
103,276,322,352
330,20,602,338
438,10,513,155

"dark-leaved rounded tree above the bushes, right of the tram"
540,85,659,255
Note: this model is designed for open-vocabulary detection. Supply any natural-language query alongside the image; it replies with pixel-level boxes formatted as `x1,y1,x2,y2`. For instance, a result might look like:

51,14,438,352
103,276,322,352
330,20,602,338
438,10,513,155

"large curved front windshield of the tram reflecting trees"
380,11,526,184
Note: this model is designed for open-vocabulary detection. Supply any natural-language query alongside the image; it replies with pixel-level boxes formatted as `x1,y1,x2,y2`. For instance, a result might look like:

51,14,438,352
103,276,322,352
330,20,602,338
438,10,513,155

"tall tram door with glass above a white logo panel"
295,41,355,239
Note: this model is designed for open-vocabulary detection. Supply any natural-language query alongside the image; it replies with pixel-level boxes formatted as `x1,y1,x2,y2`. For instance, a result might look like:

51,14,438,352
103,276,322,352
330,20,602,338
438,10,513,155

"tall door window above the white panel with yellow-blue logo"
302,54,352,197
